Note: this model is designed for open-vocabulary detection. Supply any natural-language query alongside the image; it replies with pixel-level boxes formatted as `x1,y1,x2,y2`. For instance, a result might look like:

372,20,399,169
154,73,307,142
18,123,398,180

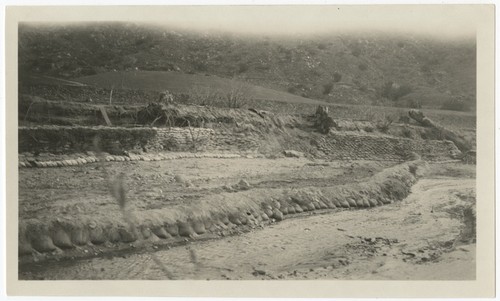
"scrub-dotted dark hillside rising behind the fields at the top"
19,23,476,110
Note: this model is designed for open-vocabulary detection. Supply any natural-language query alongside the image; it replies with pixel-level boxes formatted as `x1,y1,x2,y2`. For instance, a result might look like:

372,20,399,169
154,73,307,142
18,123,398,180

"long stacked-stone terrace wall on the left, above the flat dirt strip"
18,126,261,155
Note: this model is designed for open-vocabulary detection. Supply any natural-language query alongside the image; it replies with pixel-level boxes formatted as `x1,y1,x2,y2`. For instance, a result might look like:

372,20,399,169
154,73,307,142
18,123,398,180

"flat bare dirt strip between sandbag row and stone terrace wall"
19,158,396,220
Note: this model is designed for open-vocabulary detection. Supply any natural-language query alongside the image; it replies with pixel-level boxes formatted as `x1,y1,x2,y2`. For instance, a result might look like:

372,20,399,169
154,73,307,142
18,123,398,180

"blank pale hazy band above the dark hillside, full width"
15,5,484,38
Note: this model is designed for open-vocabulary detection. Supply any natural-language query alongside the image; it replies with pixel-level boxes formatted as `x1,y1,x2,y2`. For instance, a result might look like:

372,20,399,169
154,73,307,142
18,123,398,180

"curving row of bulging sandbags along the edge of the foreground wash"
19,161,425,255
